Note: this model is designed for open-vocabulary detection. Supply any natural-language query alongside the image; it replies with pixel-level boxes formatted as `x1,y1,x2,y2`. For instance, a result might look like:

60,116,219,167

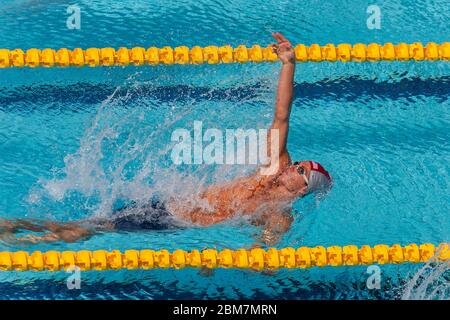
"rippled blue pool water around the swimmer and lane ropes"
0,0,450,299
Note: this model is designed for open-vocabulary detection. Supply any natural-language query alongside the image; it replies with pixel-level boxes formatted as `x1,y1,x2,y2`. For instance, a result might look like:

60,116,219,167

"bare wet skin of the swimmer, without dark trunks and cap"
0,33,311,245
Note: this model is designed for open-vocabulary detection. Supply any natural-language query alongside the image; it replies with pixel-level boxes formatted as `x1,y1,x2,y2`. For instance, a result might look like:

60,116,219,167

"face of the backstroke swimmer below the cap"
278,162,309,196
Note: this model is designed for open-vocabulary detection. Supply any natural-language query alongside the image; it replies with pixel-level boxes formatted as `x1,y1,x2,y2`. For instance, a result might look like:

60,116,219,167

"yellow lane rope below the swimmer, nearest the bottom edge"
0,243,450,271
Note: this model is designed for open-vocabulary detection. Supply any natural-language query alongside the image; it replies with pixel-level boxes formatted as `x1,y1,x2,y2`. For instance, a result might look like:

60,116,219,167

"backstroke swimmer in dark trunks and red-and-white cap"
0,33,332,245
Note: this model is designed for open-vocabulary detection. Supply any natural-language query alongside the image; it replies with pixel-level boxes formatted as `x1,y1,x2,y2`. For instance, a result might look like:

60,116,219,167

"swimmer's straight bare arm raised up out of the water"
267,32,295,168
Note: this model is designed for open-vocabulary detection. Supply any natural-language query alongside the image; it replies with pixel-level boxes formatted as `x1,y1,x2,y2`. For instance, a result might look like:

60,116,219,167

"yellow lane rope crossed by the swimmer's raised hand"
0,42,450,68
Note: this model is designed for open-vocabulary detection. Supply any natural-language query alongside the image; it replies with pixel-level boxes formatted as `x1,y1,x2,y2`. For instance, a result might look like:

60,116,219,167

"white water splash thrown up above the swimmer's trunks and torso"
28,78,264,219
